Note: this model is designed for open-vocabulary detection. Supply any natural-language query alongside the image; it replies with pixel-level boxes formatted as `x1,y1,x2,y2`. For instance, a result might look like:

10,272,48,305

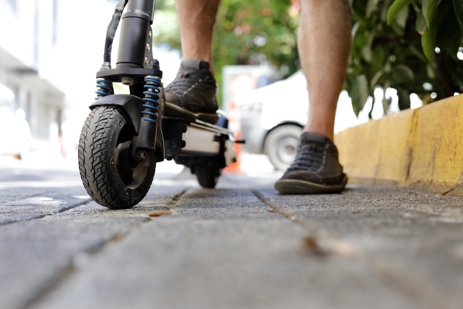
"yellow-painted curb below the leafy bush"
335,95,463,195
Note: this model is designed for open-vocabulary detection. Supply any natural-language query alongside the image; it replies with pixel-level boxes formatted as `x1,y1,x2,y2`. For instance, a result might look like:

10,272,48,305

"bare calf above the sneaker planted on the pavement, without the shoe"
298,0,352,140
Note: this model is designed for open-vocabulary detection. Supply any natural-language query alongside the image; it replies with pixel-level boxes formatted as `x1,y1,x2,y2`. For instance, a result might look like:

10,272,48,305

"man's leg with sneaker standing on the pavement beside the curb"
275,0,352,194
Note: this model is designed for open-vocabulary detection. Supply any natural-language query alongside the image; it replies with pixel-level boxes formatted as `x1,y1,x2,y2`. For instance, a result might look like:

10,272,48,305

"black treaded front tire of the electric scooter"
78,106,156,209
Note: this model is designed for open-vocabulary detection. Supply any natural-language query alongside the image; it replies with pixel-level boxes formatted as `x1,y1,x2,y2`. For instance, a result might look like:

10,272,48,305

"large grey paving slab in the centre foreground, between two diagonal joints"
33,190,419,308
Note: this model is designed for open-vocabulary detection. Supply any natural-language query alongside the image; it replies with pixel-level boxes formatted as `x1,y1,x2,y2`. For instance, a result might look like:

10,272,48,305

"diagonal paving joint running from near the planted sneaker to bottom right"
251,190,459,309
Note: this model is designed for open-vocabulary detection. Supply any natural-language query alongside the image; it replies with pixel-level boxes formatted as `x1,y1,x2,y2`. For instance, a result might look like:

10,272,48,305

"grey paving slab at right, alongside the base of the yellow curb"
264,188,463,308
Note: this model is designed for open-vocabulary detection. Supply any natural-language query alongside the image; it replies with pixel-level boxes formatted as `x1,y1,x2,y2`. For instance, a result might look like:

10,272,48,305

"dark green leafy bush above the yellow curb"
345,0,463,116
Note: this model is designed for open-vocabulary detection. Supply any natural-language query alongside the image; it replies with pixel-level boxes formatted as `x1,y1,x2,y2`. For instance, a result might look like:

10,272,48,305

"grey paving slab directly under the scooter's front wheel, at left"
0,187,188,308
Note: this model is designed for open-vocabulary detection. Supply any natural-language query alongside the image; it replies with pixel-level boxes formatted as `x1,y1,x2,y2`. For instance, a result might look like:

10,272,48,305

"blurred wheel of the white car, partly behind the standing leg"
264,125,302,170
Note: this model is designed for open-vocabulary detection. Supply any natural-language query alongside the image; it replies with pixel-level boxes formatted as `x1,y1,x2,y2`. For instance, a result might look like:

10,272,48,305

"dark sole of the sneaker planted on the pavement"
275,176,348,194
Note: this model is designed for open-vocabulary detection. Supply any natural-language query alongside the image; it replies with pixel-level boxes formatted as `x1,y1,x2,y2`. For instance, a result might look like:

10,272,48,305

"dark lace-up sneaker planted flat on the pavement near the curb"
275,132,347,194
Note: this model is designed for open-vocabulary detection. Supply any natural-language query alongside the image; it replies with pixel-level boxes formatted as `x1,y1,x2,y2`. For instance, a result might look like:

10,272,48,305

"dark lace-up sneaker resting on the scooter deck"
165,59,218,114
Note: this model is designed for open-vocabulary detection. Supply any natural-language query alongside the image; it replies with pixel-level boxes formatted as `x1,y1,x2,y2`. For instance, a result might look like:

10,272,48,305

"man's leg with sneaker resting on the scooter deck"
166,0,220,113
